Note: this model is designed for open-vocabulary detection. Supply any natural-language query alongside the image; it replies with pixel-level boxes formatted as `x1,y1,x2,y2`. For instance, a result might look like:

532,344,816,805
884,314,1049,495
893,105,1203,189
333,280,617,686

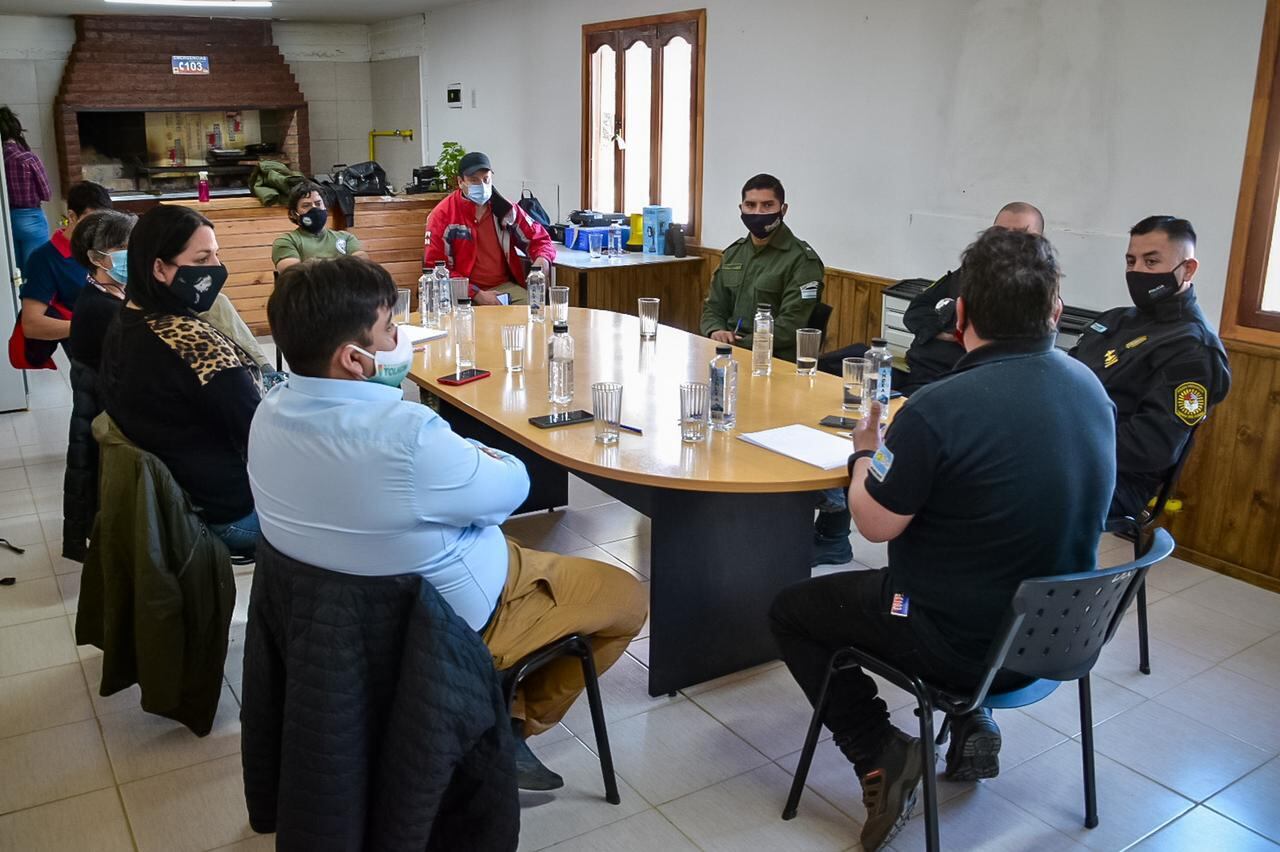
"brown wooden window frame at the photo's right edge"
1221,0,1280,348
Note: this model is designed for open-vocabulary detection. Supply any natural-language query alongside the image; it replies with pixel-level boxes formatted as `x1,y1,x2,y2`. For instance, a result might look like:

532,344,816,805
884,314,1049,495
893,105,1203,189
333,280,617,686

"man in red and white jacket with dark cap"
424,151,556,304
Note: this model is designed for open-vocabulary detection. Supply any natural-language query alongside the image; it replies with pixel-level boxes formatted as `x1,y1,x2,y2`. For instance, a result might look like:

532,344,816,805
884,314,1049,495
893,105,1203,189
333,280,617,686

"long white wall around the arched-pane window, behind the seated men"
424,0,1265,322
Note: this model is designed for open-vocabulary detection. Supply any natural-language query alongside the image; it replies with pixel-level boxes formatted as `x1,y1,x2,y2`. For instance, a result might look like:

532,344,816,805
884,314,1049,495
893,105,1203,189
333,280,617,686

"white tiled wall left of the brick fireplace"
0,15,76,226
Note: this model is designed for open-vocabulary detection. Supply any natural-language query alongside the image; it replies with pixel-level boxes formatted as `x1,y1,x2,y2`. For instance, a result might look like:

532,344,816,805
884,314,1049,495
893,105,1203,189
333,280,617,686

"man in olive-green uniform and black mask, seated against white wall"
701,174,823,361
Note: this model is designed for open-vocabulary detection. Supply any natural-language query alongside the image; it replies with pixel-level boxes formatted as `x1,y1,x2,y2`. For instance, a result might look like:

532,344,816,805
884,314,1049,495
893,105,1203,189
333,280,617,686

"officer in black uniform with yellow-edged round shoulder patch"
1071,216,1231,517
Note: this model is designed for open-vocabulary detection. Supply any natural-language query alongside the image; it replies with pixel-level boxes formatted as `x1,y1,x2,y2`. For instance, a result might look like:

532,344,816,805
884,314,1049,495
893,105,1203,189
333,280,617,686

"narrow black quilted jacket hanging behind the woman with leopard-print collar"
63,361,104,562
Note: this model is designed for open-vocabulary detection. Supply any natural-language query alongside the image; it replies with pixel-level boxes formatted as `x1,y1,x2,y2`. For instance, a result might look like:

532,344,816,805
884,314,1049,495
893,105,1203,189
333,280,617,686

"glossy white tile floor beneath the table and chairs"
0,355,1280,852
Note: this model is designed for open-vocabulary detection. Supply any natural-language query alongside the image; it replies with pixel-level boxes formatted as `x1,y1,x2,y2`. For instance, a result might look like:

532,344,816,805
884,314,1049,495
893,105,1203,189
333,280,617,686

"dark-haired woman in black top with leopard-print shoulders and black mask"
100,205,262,555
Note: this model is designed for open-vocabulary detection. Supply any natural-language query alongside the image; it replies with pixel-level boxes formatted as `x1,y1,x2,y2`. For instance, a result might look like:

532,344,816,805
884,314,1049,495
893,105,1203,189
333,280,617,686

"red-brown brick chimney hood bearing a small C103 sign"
54,15,311,187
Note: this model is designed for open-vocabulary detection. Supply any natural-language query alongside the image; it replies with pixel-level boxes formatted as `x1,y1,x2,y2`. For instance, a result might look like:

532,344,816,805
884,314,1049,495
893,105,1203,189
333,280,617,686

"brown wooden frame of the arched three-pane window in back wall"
581,9,707,242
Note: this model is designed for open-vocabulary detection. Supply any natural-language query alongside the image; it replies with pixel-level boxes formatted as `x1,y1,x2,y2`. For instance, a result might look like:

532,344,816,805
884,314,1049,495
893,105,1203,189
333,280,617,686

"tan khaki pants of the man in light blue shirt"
483,539,649,737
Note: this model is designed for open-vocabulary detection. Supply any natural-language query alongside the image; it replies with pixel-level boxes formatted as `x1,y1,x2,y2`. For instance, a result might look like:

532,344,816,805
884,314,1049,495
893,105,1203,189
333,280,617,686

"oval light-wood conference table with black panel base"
410,307,896,695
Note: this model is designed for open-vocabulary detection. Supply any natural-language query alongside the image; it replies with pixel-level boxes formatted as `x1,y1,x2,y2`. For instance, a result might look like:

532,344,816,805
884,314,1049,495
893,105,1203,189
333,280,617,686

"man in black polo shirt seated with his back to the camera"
771,228,1115,849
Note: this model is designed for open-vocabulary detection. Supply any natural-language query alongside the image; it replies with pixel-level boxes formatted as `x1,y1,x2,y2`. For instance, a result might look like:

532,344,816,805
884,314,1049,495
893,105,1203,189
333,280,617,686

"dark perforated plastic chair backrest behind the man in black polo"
982,530,1174,696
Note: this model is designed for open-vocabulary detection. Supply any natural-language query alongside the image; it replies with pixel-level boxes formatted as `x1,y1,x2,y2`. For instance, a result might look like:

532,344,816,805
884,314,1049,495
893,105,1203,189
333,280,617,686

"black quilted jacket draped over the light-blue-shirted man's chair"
241,539,520,852
